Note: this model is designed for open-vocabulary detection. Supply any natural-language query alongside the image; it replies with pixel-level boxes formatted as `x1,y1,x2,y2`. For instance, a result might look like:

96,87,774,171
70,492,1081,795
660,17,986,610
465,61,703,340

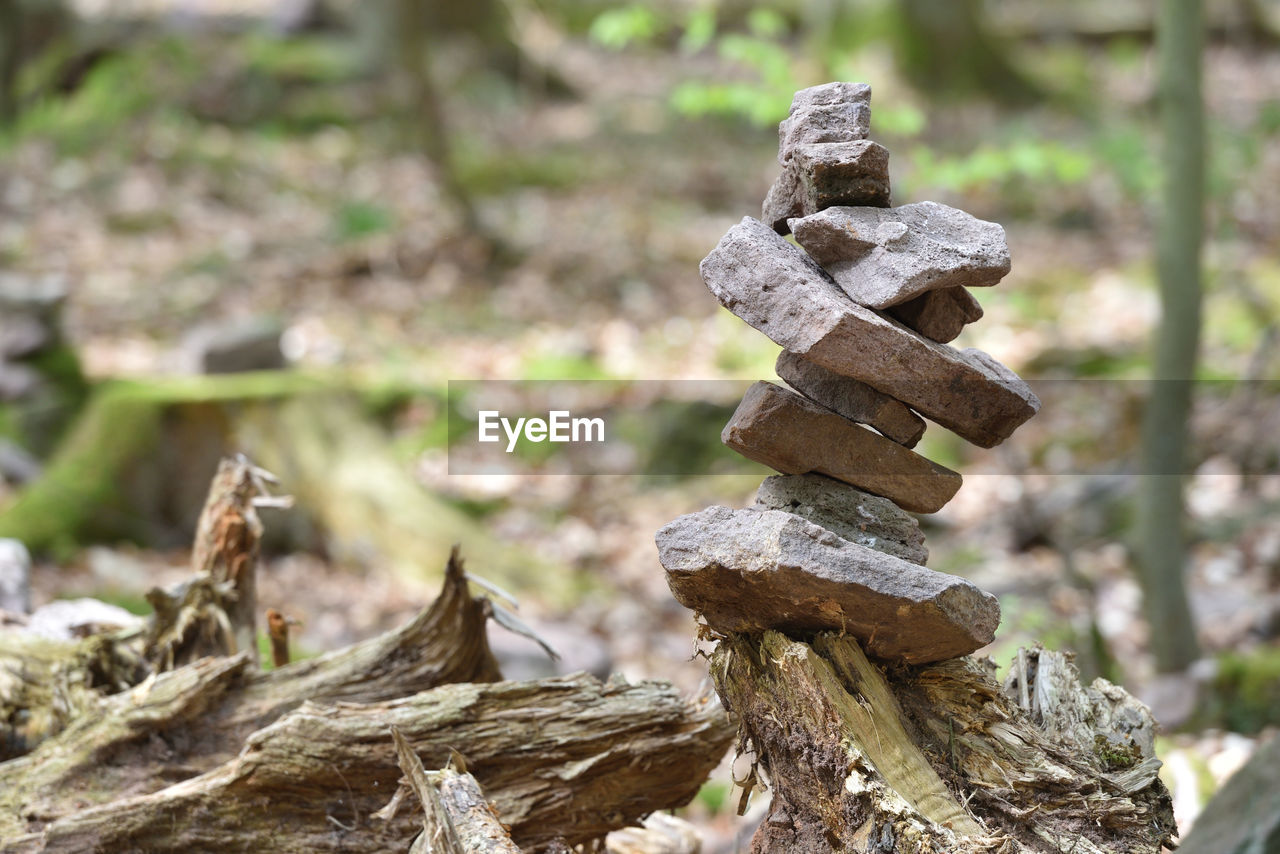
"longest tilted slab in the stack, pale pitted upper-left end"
700,216,1039,448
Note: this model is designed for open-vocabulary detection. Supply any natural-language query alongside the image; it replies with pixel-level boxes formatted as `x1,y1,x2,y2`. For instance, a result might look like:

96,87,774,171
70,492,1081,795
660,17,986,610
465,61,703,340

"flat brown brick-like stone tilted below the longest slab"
721,383,960,513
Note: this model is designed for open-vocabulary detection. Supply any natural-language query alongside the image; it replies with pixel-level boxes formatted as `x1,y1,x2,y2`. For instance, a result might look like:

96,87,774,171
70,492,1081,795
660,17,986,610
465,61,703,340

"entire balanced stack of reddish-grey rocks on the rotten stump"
657,83,1039,665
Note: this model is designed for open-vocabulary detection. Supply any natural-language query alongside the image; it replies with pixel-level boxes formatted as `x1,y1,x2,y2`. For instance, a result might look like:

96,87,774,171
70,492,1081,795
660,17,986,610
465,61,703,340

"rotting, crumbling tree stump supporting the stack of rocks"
712,631,1176,854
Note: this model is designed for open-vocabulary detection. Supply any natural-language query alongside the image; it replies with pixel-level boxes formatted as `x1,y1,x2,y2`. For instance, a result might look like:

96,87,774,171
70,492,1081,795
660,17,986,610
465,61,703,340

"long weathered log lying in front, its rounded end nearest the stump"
0,671,732,854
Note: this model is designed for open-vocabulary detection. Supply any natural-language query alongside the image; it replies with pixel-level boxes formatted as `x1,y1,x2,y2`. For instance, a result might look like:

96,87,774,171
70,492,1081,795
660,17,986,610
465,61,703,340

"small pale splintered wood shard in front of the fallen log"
388,729,520,854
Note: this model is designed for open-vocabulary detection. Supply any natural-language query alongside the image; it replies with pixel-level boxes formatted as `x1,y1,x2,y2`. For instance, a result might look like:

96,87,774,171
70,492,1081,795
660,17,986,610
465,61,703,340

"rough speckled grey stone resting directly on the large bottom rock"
755,475,929,566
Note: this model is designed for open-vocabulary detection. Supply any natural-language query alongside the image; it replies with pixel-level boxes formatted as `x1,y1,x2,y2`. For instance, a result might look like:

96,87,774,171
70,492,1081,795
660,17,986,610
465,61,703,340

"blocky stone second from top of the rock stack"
760,140,890,234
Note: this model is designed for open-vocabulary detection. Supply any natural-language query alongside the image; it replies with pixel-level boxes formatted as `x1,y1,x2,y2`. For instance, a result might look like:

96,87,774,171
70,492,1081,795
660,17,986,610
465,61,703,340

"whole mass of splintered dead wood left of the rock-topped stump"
0,460,732,854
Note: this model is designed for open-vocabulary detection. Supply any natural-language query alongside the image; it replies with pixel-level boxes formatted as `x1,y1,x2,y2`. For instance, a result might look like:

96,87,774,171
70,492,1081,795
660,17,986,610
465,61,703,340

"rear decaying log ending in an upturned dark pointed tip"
0,549,500,839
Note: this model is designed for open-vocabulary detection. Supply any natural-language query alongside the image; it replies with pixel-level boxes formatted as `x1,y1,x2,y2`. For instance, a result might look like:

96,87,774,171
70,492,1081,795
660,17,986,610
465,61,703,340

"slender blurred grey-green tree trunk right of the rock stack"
1137,0,1204,673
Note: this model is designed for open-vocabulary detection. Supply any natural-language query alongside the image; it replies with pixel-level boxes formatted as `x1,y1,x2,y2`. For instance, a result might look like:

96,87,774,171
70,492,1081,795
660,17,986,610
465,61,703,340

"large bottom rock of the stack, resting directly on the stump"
655,507,1000,665
